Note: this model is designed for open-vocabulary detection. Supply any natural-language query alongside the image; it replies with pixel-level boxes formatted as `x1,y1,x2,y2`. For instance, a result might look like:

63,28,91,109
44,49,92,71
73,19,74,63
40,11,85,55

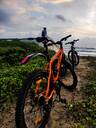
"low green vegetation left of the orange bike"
0,41,53,109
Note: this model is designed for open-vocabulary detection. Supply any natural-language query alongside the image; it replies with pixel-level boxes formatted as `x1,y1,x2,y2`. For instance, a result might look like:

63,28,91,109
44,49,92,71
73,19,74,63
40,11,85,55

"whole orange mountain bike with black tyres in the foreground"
15,36,77,128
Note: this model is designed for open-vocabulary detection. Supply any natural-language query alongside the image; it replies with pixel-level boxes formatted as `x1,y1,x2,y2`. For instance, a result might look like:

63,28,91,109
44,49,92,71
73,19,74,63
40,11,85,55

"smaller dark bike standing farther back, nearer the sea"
65,39,79,68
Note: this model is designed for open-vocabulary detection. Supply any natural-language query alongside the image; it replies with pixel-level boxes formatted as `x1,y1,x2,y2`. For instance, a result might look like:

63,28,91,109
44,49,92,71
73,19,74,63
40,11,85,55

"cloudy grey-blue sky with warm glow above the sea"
0,0,96,47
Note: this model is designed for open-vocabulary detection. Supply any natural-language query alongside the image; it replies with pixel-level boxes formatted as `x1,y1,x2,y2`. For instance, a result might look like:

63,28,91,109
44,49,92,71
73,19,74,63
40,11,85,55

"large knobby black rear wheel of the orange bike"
15,70,51,128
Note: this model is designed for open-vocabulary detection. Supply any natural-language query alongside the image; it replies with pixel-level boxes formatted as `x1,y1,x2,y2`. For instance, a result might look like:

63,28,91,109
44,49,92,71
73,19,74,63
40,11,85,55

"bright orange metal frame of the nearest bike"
35,48,64,101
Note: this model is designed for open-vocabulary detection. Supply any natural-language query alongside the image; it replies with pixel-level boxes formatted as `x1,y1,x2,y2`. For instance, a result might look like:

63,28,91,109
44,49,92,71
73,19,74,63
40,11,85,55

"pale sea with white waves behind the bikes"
22,38,96,56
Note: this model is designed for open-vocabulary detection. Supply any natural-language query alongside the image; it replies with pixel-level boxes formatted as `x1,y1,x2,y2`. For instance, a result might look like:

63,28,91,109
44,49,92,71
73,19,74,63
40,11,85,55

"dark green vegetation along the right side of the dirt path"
67,57,96,128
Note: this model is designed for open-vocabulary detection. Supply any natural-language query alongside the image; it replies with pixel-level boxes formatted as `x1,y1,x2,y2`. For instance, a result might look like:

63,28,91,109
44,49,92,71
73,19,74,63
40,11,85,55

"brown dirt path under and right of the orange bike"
47,58,90,128
